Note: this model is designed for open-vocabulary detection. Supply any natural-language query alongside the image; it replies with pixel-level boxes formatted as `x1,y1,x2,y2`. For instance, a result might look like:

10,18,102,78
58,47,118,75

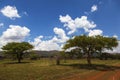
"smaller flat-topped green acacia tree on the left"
2,42,33,63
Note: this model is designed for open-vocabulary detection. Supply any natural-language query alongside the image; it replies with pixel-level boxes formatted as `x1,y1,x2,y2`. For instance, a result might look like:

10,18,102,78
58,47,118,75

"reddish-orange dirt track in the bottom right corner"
60,64,120,80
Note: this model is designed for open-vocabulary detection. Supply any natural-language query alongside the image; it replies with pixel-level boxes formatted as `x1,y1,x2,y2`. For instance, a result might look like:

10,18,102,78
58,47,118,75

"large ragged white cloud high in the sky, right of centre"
59,15,96,35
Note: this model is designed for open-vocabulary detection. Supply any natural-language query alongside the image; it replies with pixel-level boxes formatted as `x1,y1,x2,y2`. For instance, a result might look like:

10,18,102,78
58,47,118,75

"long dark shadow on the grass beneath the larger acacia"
61,64,120,71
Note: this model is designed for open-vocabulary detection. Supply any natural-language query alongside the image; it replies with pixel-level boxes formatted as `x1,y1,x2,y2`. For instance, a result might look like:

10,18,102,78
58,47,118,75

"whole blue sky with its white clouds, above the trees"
0,0,120,50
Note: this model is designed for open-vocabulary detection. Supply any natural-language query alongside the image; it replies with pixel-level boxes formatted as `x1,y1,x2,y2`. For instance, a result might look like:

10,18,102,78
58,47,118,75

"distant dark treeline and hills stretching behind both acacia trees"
0,50,120,60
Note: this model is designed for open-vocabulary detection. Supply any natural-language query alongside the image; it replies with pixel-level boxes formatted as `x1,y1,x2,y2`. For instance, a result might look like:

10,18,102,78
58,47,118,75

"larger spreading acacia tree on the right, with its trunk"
63,35,118,65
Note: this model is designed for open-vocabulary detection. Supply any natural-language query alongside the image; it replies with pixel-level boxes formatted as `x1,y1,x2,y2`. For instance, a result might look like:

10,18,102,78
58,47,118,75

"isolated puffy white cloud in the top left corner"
0,5,21,19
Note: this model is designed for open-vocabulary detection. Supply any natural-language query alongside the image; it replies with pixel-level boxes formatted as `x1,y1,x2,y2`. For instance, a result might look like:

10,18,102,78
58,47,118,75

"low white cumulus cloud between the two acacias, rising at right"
30,27,69,51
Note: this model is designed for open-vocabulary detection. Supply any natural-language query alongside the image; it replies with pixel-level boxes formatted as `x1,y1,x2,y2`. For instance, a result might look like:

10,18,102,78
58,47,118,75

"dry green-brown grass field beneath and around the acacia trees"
0,59,120,80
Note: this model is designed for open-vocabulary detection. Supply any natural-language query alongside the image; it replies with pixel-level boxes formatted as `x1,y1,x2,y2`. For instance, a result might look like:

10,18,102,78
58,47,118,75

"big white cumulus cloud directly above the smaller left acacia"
0,25,30,47
